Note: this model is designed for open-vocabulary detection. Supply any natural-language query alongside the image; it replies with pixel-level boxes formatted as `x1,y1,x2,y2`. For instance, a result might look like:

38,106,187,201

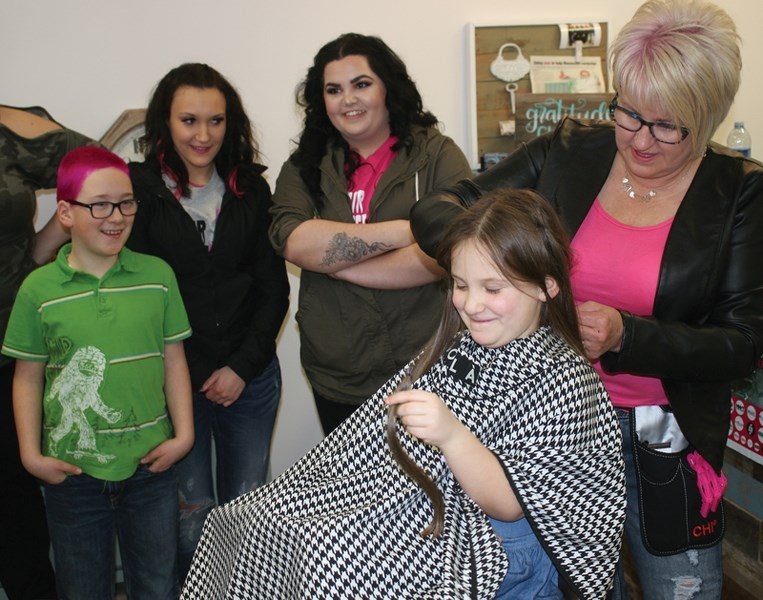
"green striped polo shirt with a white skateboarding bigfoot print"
2,244,191,481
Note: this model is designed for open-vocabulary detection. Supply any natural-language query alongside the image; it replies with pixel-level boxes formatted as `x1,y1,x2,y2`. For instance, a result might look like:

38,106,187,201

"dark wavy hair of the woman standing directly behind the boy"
142,63,262,197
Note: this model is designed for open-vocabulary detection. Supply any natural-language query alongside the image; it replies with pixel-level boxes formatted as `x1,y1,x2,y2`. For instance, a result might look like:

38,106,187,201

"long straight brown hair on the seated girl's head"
412,188,585,379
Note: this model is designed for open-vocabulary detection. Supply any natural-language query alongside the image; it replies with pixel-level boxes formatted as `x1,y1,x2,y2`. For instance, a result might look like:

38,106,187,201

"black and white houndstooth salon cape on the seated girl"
182,328,625,600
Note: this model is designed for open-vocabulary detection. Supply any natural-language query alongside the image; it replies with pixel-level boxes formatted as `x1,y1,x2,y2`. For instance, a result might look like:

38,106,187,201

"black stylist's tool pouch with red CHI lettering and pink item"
631,406,727,555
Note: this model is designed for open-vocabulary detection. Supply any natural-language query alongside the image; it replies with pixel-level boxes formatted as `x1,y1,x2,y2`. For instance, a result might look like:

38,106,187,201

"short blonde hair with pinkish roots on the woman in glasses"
609,0,742,156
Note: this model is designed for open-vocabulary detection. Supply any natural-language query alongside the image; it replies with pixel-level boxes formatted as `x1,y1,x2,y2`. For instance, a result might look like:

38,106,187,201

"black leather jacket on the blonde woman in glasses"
411,118,763,471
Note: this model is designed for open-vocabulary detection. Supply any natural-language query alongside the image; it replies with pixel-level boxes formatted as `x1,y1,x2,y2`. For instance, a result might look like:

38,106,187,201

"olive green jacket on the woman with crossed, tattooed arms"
270,128,471,404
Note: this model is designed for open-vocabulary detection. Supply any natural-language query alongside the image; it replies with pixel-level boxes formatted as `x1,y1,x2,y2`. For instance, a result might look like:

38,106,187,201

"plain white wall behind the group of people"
0,0,763,474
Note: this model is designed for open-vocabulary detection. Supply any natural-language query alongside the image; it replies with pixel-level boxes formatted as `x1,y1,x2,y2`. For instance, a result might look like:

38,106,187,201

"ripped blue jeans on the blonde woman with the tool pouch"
612,409,723,600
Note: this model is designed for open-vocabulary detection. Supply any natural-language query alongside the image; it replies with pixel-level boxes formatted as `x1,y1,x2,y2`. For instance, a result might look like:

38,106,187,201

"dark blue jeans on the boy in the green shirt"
45,465,178,600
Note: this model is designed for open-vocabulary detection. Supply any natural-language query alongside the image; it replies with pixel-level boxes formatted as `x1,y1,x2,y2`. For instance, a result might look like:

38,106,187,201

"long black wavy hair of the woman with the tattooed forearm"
291,33,437,200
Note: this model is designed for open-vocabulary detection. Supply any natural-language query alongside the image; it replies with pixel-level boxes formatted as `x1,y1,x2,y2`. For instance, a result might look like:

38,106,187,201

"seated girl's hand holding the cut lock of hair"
385,390,466,449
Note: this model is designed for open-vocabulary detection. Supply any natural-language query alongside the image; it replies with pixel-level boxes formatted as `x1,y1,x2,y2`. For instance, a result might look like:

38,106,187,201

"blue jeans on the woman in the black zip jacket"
177,357,281,582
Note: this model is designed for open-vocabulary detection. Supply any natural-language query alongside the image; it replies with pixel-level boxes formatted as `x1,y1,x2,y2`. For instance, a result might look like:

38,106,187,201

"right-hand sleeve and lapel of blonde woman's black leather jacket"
602,151,763,383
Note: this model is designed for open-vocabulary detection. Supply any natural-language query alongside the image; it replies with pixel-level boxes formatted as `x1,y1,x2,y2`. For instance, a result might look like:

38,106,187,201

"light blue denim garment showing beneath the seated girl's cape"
488,517,563,600
